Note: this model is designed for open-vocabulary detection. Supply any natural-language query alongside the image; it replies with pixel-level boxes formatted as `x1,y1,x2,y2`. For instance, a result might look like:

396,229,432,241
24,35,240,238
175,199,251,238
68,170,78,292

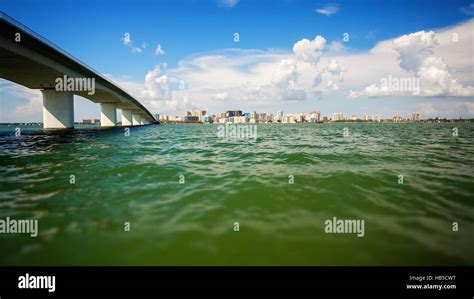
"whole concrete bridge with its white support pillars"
0,12,156,129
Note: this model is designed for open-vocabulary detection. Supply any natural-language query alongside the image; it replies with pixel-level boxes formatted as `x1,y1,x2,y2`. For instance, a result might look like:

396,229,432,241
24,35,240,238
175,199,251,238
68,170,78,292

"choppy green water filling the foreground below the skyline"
0,123,474,265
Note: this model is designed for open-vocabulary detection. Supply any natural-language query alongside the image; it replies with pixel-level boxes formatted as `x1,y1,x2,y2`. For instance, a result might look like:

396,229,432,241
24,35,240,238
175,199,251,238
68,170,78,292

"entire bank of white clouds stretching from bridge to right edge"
5,20,474,120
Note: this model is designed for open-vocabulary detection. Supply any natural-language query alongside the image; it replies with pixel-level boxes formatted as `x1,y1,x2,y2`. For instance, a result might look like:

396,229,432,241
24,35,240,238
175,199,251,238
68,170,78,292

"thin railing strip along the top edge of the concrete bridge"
0,11,154,119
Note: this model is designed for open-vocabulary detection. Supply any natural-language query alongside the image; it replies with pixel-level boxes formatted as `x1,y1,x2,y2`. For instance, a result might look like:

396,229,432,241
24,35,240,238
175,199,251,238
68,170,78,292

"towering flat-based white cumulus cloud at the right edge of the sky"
348,21,474,98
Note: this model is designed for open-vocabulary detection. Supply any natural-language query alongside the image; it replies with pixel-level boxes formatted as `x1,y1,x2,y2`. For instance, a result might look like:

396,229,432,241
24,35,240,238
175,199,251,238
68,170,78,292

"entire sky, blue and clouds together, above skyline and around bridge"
0,0,474,122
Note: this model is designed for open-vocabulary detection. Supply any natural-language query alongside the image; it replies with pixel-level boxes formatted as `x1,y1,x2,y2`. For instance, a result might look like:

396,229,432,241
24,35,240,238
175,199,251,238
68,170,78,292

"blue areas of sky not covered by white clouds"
0,0,472,122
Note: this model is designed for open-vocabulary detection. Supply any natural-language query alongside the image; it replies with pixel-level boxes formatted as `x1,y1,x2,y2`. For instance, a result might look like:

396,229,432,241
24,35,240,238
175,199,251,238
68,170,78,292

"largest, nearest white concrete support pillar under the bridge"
41,89,74,129
